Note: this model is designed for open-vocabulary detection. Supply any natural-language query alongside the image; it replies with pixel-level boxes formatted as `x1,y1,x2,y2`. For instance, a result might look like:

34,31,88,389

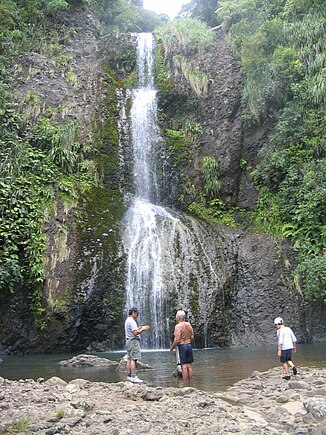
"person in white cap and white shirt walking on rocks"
274,317,297,381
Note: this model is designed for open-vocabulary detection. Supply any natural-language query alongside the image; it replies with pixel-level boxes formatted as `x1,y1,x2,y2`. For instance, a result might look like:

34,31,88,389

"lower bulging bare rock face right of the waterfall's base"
168,223,310,347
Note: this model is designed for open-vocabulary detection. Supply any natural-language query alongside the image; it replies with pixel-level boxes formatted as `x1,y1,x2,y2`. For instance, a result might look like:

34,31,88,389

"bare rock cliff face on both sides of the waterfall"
0,7,326,352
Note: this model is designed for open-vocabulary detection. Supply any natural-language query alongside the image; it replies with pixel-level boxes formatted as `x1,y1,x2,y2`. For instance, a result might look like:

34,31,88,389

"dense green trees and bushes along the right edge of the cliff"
218,0,326,301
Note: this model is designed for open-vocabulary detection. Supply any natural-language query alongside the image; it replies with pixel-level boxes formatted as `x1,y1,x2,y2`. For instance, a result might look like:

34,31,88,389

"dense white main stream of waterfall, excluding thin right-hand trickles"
123,33,169,348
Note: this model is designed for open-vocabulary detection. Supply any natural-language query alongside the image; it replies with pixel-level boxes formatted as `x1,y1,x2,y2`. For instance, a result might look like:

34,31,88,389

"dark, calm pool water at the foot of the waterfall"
0,343,326,392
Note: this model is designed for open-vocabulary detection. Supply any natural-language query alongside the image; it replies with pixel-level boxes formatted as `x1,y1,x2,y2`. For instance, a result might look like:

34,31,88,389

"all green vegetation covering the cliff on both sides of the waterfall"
0,0,326,334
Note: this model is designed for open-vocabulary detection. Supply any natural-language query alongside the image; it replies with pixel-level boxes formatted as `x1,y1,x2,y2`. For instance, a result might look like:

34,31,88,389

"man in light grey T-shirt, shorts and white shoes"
125,307,150,384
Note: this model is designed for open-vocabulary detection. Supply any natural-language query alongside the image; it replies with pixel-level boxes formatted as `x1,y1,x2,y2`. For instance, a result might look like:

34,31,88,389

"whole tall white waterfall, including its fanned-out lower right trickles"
122,34,220,349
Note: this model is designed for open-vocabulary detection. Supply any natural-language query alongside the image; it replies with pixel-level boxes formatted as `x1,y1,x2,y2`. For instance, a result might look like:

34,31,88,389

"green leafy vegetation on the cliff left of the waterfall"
0,0,129,329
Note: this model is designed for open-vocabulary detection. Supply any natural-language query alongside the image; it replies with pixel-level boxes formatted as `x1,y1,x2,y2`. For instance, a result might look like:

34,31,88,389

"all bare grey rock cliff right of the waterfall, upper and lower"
155,28,325,346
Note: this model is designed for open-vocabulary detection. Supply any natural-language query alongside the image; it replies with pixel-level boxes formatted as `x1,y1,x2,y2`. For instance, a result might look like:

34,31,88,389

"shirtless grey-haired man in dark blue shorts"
170,310,194,384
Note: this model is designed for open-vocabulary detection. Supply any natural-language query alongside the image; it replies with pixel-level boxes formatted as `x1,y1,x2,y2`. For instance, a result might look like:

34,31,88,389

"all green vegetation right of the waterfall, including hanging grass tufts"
156,0,326,301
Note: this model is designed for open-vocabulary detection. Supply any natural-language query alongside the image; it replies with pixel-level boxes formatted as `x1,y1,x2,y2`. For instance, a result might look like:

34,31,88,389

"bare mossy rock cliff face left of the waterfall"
0,11,130,352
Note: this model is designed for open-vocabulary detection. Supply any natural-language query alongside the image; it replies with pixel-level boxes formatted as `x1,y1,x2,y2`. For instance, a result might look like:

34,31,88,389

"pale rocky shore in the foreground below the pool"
0,367,326,435
